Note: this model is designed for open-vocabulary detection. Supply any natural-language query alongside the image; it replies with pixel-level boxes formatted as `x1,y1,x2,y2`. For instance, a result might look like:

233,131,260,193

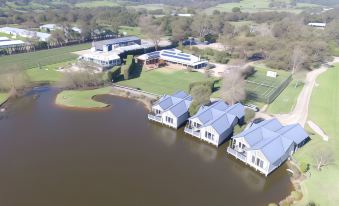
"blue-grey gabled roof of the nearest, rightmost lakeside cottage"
233,119,309,163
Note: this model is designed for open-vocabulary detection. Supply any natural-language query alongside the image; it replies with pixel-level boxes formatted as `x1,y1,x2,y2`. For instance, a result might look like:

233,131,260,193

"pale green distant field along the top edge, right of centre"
206,0,319,13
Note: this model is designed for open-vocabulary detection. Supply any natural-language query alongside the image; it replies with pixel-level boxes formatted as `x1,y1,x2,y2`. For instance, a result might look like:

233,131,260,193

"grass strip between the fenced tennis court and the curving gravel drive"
268,80,304,114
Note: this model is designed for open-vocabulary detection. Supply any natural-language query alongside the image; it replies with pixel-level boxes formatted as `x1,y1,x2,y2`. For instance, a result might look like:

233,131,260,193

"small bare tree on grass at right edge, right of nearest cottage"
313,148,335,171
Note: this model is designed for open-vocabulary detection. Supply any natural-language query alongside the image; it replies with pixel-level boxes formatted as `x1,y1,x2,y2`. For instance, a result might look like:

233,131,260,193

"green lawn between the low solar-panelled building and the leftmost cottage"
118,68,211,94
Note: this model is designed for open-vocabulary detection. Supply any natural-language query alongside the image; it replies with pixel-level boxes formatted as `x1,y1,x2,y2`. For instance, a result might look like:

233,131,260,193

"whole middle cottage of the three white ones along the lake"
185,101,245,146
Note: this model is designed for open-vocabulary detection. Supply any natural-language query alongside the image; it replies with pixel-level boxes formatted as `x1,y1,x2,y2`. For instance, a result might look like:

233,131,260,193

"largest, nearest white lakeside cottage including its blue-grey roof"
227,119,309,176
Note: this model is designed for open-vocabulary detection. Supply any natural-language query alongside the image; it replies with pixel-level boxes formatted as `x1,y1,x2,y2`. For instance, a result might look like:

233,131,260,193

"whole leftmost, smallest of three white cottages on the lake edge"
148,91,192,129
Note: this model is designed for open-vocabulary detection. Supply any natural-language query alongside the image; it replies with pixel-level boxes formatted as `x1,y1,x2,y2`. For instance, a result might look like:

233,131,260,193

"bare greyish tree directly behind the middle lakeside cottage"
220,69,246,105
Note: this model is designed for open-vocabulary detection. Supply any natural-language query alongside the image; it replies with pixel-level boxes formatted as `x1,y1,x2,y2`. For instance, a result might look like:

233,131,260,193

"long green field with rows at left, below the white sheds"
0,44,90,70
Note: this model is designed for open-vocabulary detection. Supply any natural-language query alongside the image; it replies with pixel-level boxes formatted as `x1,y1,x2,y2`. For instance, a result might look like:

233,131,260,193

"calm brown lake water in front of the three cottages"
0,88,292,206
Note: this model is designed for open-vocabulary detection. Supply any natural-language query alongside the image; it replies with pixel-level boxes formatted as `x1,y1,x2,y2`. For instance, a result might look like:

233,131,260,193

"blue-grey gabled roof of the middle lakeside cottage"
190,101,244,134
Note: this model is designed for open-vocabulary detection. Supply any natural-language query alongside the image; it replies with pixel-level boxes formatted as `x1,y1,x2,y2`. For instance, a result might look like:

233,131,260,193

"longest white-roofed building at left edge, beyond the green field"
0,27,51,41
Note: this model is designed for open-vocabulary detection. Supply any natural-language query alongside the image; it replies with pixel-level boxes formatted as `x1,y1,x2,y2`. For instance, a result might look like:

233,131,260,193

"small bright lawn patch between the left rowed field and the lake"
26,61,74,82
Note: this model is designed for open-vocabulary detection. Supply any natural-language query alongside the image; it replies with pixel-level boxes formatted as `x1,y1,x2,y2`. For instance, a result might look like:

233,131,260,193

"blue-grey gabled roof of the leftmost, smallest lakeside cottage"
153,91,192,117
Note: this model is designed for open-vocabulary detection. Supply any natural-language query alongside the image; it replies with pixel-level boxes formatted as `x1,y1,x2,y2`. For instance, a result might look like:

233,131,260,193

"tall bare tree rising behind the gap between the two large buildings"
139,16,163,50
